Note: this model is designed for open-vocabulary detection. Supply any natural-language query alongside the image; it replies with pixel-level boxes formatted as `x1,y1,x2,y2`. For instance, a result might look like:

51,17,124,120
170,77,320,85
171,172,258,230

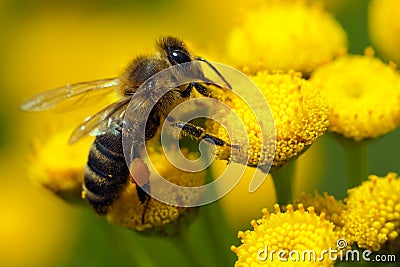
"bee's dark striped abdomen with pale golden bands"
83,131,129,215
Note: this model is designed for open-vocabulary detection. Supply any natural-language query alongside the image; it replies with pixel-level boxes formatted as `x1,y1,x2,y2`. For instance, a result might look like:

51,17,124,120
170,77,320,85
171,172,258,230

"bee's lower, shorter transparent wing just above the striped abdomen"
69,97,131,144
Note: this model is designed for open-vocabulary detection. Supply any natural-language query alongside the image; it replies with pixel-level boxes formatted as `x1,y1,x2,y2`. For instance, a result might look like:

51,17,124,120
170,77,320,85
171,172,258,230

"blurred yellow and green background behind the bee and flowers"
0,0,400,266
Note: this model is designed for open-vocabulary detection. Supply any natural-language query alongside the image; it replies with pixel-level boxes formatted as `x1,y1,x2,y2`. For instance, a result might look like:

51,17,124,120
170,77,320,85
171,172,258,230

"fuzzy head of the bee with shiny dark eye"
157,36,193,65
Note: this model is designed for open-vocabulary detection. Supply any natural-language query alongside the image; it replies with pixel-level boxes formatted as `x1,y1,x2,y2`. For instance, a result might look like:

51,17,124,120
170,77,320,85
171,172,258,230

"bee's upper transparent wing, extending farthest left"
20,78,119,111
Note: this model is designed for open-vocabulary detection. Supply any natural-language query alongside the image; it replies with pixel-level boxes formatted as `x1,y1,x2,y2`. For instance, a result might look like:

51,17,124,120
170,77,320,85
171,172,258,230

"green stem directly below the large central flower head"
271,160,295,205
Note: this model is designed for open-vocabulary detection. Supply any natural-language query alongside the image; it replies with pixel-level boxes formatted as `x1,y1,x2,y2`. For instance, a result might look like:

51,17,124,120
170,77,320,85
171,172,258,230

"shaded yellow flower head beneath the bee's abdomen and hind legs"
106,150,206,235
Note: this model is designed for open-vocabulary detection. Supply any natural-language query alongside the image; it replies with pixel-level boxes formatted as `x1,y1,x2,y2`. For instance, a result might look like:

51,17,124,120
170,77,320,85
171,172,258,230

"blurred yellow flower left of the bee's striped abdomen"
28,125,93,202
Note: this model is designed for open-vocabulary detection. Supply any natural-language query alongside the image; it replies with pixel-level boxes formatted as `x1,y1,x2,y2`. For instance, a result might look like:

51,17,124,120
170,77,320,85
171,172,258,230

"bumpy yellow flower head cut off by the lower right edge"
342,173,400,251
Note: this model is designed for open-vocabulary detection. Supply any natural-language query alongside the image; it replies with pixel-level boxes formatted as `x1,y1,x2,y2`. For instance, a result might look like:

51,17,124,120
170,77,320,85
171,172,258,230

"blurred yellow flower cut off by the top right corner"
368,0,400,64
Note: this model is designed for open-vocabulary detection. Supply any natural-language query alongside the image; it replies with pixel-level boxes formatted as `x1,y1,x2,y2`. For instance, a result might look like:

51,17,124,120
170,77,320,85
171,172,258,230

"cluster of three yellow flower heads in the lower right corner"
232,173,400,266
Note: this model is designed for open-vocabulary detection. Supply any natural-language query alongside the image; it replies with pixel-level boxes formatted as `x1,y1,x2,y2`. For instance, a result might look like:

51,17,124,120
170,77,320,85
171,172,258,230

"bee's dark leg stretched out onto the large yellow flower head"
167,116,238,148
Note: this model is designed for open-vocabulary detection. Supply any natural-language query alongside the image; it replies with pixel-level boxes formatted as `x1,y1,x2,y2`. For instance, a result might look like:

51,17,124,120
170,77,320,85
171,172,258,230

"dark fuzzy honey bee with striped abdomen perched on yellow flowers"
20,37,231,215
